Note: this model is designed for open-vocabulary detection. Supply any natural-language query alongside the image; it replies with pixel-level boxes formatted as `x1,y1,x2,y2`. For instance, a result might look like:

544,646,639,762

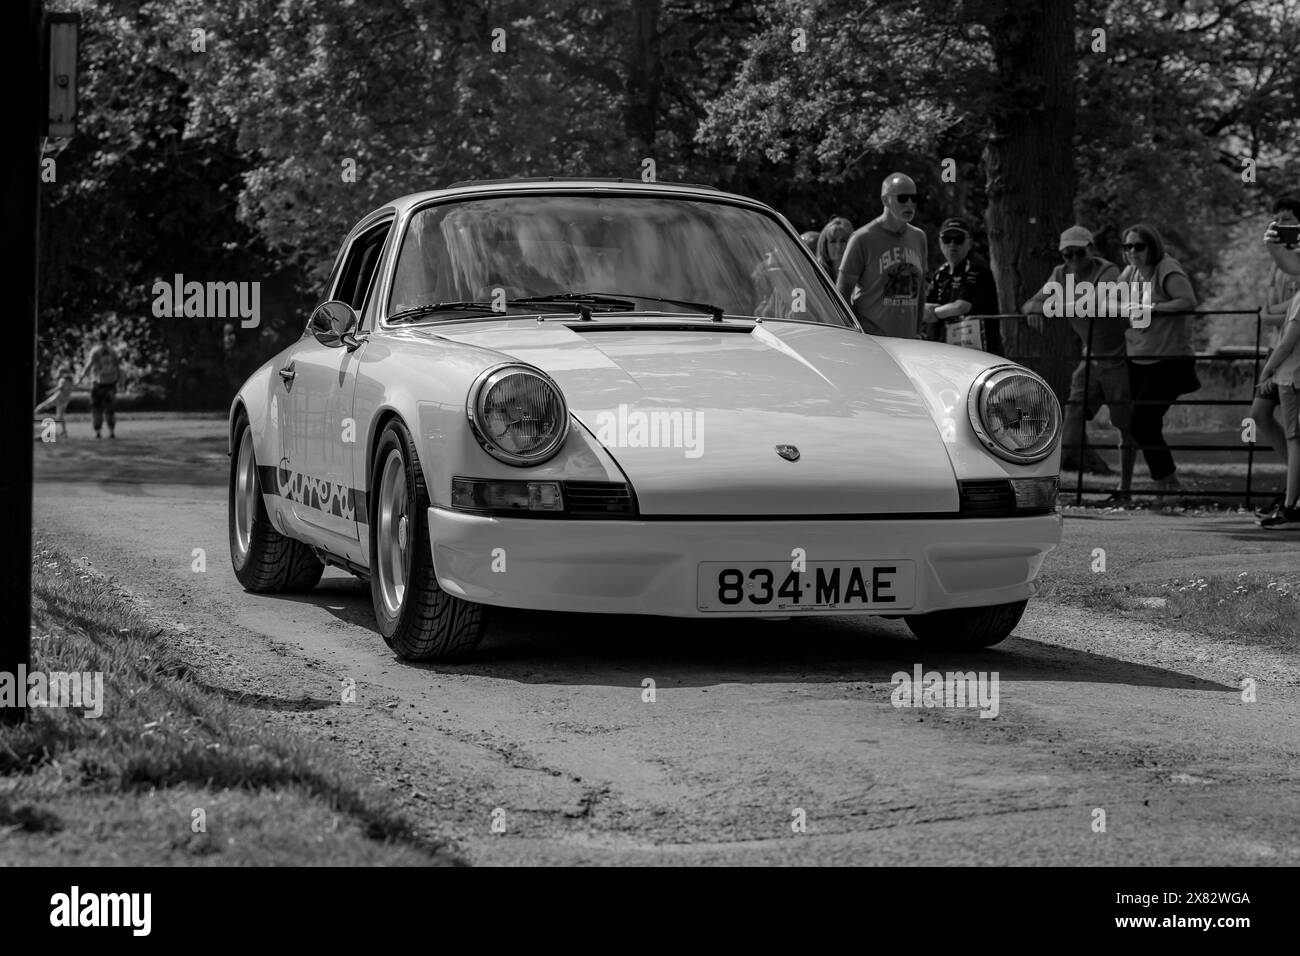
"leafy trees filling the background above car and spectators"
40,0,1300,406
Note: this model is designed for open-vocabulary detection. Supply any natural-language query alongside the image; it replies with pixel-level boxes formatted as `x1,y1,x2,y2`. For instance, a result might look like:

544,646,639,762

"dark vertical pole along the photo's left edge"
0,0,48,723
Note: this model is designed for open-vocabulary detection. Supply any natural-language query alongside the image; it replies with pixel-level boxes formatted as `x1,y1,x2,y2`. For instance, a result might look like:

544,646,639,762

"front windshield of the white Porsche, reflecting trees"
387,195,853,328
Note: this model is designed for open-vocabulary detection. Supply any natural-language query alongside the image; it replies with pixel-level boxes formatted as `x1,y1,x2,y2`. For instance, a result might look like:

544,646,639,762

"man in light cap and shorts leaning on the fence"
1021,225,1132,489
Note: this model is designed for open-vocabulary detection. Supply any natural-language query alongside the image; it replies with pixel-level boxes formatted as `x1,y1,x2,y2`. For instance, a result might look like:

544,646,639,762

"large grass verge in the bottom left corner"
0,542,458,865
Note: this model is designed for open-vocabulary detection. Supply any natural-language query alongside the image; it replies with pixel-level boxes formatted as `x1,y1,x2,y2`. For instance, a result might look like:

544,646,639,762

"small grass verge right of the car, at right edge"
1048,571,1300,652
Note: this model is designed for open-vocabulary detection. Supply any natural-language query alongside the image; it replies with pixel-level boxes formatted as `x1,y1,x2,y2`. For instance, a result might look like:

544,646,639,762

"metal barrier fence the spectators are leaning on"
965,308,1271,507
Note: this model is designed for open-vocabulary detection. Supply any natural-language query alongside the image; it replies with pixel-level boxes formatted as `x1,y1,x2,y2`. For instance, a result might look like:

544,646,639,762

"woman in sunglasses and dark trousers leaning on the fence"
1119,222,1201,492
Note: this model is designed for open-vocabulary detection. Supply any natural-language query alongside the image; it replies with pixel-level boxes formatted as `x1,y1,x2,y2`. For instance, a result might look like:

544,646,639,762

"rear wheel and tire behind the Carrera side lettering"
226,415,325,594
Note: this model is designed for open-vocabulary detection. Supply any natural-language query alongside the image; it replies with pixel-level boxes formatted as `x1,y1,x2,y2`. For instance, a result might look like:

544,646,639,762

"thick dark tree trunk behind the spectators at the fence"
980,0,1079,401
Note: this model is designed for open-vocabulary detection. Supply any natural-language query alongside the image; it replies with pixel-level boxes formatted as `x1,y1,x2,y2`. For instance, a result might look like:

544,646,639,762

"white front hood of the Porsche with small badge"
421,319,958,515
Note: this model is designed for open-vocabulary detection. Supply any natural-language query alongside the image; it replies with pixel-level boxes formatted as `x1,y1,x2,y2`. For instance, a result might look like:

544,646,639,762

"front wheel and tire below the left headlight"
369,419,488,661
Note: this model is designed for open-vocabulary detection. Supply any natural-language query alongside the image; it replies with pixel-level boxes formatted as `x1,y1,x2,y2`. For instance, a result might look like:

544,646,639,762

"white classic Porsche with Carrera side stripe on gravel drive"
229,179,1061,659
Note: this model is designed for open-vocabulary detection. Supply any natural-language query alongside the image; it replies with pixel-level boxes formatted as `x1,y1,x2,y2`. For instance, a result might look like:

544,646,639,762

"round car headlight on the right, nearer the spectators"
966,365,1061,464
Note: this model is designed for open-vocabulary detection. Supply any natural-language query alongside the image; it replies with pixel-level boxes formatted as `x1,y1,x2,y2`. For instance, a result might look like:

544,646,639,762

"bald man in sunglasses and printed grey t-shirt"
835,173,927,338
